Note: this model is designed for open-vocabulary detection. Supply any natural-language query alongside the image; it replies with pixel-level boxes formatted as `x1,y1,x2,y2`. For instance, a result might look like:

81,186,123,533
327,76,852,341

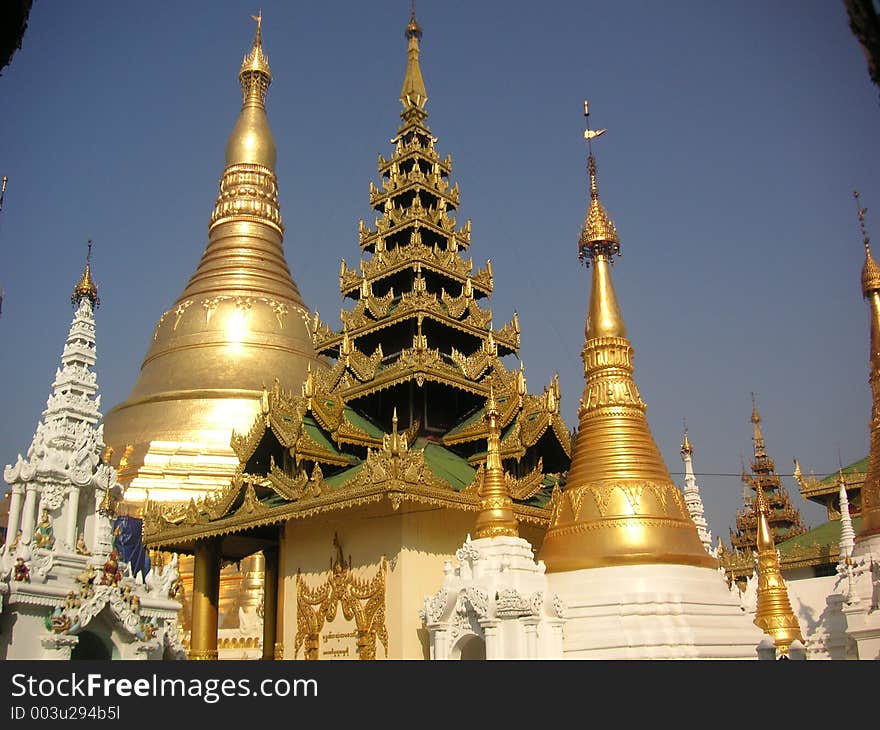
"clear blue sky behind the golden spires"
0,0,880,540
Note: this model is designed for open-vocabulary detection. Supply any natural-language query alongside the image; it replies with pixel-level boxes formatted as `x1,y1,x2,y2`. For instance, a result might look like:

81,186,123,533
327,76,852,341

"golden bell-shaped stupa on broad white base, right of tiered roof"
540,102,717,572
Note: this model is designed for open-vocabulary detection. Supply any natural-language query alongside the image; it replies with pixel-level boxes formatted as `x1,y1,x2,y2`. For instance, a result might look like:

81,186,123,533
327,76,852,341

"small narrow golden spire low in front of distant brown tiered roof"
754,483,803,654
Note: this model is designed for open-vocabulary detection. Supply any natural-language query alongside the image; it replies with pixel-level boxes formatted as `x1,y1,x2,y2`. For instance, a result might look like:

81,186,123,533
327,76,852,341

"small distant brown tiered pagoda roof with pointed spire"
730,398,807,555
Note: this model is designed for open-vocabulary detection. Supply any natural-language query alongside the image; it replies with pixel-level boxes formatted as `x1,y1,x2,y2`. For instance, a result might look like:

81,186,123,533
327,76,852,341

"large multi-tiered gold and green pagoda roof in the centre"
145,15,571,544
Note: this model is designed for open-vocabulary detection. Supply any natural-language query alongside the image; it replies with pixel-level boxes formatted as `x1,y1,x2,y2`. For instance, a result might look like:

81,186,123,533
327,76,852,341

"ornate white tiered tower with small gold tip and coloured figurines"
0,242,182,659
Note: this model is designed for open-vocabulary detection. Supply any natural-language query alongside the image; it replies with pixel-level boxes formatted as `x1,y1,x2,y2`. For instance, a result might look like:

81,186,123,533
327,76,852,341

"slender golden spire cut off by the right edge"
853,191,880,543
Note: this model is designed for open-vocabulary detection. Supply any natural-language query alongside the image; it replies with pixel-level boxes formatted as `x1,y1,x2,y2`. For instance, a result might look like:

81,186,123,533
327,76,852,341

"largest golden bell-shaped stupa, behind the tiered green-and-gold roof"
105,15,320,504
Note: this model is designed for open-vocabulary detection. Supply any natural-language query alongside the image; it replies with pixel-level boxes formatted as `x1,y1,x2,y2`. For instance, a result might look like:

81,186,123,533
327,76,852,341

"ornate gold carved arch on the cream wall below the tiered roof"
293,535,388,660
